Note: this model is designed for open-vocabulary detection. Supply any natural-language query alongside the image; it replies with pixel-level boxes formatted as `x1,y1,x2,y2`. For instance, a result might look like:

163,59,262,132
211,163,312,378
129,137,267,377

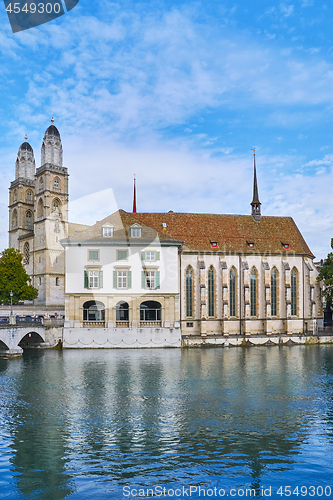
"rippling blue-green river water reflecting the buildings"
0,345,333,500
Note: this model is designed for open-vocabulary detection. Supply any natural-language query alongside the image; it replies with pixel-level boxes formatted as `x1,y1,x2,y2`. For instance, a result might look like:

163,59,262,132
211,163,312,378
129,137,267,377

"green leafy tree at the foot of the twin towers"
0,248,38,304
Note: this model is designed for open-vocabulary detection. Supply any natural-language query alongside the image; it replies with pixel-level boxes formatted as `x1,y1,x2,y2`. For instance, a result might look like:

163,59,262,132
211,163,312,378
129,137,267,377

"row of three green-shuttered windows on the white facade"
84,269,160,290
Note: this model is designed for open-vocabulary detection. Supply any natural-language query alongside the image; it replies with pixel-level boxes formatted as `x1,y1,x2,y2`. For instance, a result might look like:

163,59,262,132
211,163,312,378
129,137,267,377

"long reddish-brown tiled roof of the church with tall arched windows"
131,212,314,257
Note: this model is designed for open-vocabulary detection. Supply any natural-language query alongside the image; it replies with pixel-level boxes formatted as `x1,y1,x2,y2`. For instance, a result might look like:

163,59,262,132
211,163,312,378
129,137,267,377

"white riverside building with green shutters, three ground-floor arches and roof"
62,210,181,348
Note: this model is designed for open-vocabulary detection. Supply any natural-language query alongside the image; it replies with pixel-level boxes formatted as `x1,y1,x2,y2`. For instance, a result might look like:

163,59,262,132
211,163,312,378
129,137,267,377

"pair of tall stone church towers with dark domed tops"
9,118,68,308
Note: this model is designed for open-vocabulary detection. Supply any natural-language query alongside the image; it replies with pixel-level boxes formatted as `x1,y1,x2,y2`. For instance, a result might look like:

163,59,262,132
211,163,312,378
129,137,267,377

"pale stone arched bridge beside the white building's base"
0,323,62,356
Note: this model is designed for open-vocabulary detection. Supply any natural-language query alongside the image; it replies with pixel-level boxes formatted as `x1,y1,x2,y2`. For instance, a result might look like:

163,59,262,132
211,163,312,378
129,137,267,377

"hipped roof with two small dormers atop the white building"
62,210,182,245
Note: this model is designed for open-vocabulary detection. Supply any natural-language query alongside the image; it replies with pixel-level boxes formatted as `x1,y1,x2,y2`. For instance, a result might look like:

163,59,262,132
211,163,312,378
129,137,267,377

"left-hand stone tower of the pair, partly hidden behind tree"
9,136,36,253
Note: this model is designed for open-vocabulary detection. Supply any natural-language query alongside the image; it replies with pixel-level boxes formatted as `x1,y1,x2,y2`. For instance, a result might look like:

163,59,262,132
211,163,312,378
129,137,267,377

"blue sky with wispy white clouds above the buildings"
0,0,333,260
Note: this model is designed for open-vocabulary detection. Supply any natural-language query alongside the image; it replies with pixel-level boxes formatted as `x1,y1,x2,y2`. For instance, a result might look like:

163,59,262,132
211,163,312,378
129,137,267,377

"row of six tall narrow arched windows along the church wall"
185,266,297,318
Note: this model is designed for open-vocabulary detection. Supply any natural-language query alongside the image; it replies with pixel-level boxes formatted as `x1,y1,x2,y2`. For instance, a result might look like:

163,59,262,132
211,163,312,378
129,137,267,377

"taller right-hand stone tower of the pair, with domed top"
34,118,68,306
